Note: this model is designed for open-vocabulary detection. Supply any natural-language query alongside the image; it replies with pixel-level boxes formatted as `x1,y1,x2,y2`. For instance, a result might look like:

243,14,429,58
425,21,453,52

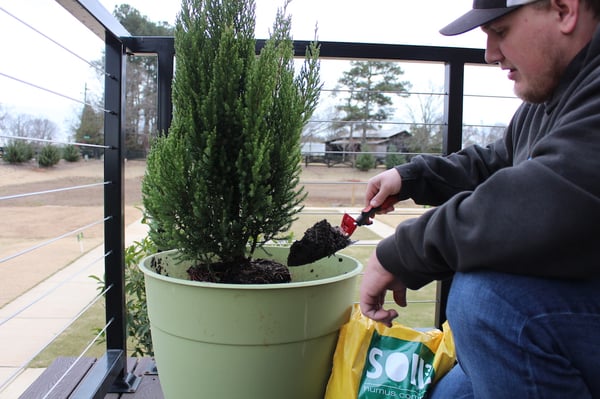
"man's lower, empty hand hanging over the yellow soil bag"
360,252,406,327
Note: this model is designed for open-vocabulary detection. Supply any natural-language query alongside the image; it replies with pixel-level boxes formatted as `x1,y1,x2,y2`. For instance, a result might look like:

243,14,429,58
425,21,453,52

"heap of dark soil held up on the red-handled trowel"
288,219,352,266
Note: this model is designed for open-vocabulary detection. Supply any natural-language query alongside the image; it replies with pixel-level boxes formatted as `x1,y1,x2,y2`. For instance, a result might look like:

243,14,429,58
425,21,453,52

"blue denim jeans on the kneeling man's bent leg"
429,271,600,399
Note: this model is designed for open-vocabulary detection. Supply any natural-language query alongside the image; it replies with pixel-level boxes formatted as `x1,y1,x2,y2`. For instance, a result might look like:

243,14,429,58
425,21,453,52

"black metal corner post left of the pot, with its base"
70,32,140,399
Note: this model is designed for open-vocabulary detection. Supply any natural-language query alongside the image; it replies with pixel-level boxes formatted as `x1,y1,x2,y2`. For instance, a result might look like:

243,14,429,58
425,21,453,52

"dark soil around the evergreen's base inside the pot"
187,259,292,284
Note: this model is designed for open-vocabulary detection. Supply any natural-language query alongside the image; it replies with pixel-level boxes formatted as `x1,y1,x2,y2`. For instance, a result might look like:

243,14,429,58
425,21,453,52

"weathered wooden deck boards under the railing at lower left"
19,357,164,399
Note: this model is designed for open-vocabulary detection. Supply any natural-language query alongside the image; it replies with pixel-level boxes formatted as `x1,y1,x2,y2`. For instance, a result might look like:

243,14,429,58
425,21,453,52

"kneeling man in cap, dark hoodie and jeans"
360,0,600,399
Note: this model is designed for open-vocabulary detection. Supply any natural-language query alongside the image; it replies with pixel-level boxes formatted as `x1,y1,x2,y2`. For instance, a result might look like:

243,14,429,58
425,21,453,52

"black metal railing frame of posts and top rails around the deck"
56,0,485,399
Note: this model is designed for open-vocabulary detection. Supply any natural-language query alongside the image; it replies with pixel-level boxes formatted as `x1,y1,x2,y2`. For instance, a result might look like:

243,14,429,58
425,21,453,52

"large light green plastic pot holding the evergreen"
140,246,362,399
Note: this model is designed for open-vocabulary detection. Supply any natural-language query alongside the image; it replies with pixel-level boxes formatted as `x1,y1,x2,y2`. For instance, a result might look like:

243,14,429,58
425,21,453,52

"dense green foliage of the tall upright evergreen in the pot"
142,0,321,264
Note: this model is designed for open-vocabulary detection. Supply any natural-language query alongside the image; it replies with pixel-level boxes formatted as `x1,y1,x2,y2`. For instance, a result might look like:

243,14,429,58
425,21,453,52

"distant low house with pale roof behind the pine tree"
325,129,411,159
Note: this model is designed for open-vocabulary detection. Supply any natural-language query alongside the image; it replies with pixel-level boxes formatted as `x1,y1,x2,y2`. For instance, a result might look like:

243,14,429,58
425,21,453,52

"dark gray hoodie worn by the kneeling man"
376,31,600,289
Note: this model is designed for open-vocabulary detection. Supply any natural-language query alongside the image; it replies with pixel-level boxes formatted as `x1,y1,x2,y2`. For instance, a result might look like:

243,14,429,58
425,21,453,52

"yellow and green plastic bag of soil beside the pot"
325,305,456,399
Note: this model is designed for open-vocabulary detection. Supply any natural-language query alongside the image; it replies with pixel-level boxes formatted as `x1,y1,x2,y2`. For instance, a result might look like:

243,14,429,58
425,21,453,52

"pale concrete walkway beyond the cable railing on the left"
0,221,147,399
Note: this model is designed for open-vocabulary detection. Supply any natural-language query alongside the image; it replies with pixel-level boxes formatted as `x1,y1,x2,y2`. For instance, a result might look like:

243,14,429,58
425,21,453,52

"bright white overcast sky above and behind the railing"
0,0,519,141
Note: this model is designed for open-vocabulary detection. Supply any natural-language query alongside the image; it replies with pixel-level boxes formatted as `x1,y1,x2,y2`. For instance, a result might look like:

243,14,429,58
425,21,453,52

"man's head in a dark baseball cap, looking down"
440,0,600,103
